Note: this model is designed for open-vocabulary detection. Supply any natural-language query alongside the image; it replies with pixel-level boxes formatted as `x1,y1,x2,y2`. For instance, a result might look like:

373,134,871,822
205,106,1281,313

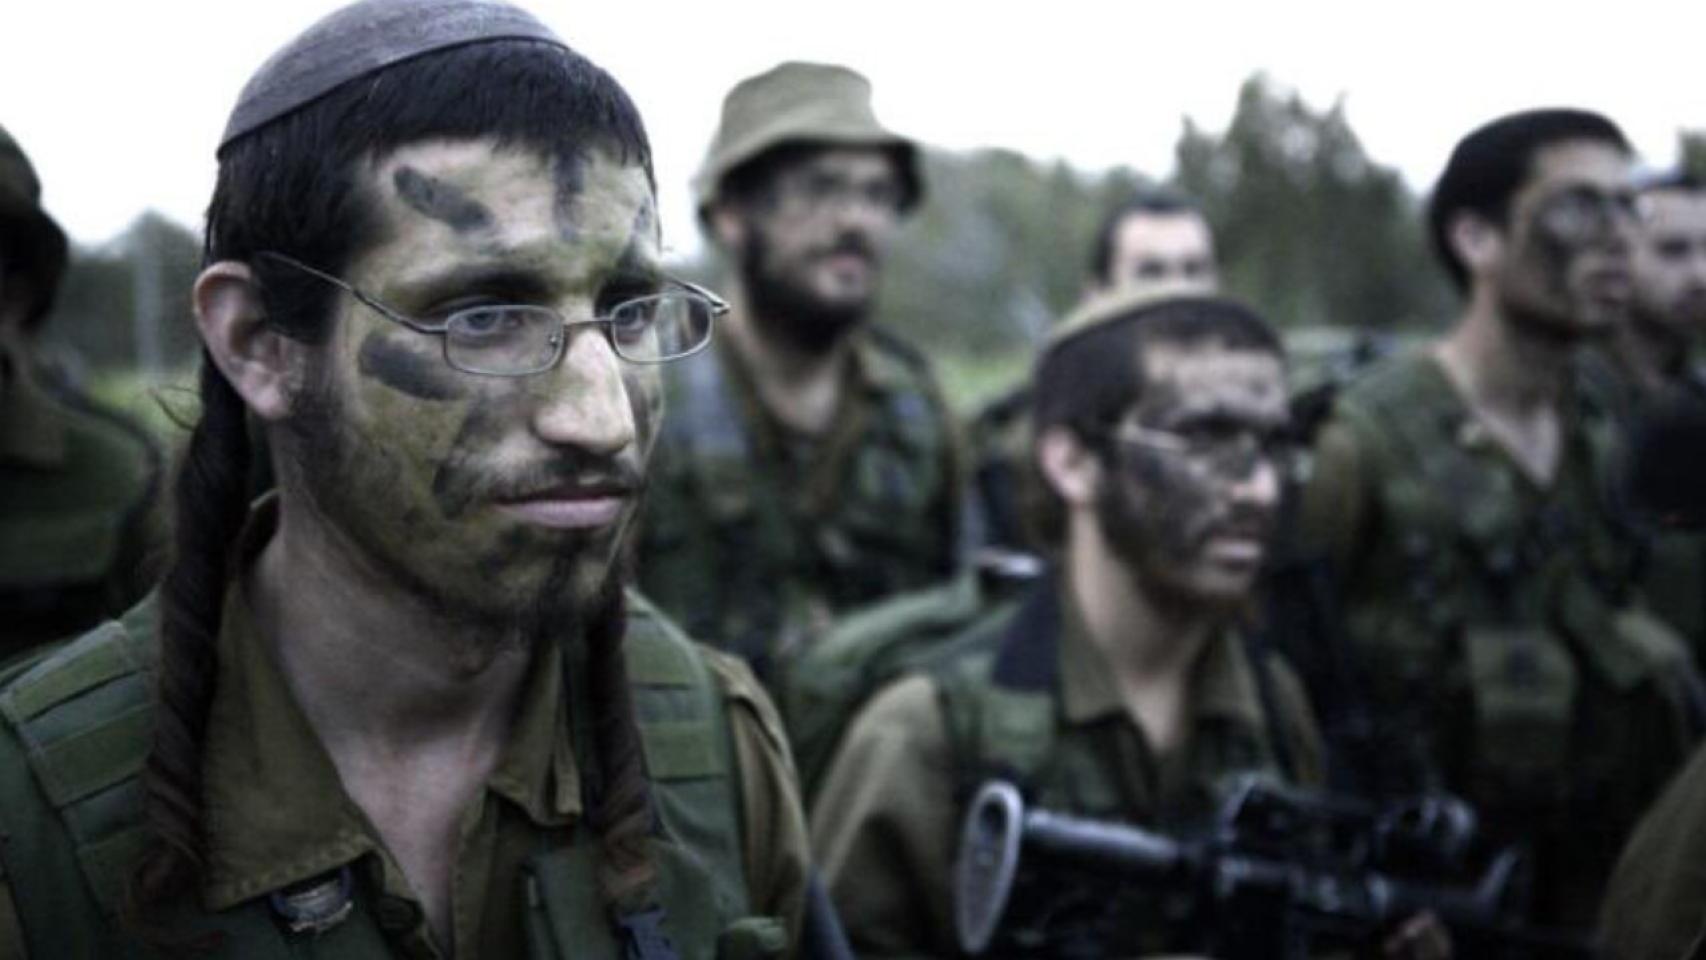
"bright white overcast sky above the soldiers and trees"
0,0,1706,251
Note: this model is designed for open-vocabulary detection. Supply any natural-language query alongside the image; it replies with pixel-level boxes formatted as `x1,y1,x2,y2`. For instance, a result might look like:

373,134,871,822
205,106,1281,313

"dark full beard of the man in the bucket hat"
737,230,875,356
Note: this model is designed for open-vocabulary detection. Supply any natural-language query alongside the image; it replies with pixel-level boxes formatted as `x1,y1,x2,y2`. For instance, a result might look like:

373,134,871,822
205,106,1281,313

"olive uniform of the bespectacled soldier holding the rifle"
812,581,1320,957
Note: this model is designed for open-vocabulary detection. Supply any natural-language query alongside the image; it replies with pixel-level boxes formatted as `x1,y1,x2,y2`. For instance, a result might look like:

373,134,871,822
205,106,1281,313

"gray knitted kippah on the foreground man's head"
220,0,563,150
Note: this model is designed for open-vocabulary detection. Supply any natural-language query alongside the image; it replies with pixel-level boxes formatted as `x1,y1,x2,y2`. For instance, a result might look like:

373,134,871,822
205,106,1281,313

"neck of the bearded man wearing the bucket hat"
723,288,851,433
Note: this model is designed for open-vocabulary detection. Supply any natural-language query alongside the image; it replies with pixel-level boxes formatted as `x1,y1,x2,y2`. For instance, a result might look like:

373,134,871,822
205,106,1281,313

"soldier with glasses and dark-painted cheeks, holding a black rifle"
812,293,1385,957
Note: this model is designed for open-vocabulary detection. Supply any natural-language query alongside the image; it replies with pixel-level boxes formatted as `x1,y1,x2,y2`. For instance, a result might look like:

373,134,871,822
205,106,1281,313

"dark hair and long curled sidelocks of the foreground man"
128,41,652,934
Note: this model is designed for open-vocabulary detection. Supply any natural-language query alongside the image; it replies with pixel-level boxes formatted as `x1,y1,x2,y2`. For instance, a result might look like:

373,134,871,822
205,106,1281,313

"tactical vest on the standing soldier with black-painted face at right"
1334,355,1691,824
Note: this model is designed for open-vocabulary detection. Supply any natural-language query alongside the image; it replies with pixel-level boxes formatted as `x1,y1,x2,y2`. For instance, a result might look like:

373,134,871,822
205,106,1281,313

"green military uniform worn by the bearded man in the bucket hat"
638,331,959,675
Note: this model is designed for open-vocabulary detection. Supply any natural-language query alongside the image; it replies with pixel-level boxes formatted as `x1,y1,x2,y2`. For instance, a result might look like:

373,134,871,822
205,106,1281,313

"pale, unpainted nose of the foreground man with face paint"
529,326,635,457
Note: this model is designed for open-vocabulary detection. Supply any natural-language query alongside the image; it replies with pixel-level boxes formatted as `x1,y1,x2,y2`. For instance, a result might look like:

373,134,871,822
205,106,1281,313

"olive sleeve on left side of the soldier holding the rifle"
812,675,959,957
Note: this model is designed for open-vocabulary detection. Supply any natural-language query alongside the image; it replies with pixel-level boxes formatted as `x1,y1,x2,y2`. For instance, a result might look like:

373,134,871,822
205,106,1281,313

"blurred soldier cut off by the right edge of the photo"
1583,174,1706,663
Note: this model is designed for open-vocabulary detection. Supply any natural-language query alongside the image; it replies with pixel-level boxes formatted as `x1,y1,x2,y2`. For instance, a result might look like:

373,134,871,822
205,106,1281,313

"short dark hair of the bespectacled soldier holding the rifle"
1024,297,1285,549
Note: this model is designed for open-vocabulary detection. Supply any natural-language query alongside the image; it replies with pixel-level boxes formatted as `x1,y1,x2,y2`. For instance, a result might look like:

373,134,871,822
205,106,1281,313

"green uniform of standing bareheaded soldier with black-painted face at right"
1302,353,1697,926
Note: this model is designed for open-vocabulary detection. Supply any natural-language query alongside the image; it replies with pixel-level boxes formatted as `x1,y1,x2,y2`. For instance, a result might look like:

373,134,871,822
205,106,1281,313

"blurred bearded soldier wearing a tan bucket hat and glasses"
638,63,959,677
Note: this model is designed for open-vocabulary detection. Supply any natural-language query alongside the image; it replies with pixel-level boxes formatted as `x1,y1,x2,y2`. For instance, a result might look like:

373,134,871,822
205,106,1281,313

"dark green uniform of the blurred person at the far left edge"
0,346,164,656
